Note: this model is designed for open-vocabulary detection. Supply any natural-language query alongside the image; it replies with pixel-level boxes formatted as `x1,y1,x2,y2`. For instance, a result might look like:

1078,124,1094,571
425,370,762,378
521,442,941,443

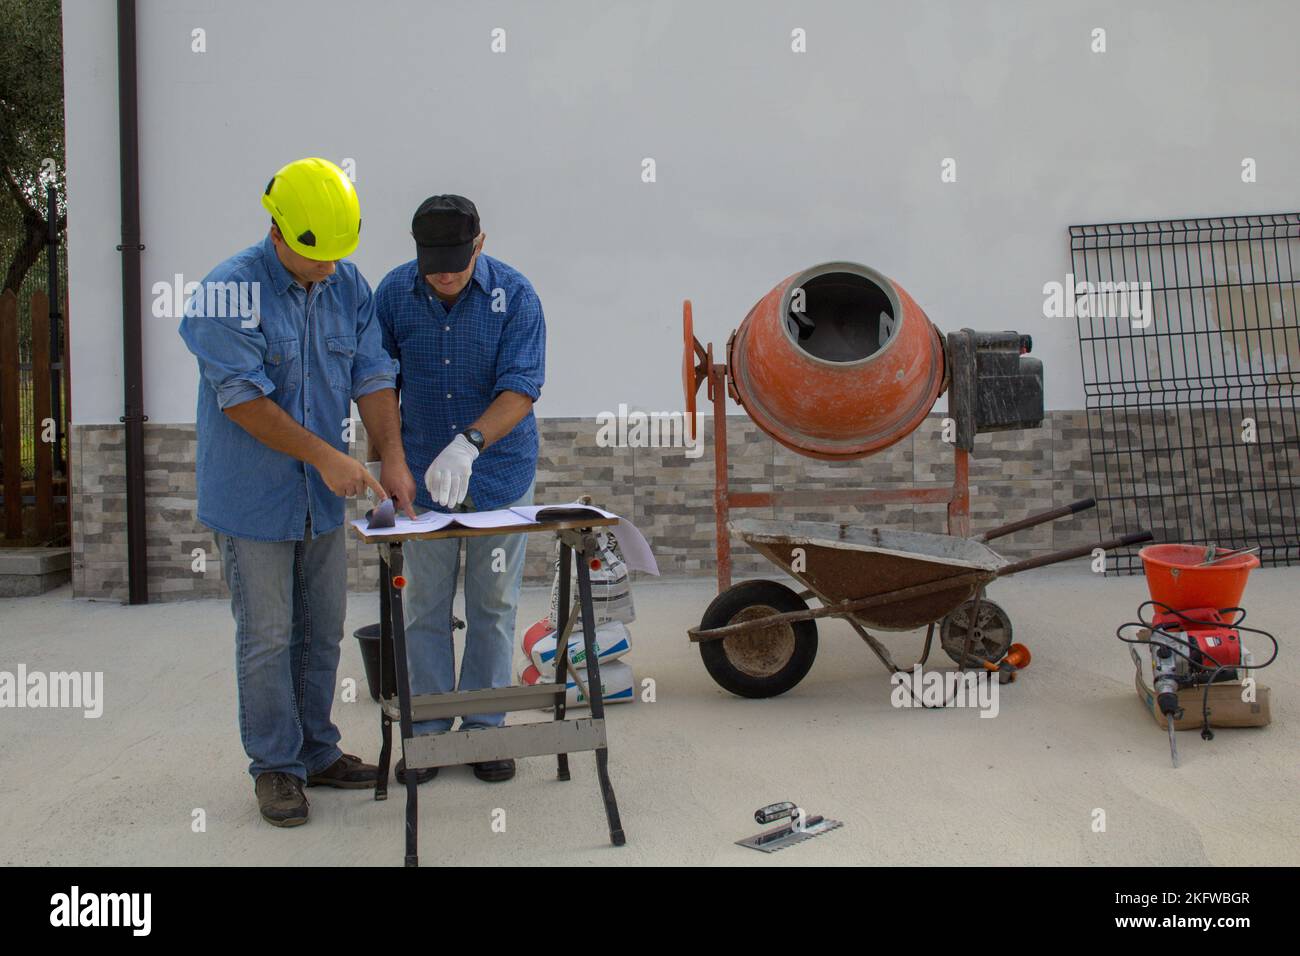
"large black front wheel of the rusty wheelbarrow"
699,580,816,697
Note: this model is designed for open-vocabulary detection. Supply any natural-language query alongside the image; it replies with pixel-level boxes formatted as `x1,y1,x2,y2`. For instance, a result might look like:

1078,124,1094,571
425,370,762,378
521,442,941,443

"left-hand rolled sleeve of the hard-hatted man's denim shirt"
181,282,276,410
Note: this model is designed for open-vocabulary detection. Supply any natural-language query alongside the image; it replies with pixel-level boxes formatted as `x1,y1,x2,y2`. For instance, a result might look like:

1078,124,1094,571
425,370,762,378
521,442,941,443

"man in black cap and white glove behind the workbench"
374,195,546,782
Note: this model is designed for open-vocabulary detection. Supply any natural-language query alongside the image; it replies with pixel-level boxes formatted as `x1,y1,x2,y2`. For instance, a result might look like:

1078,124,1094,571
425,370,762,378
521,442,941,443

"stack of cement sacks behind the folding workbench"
519,527,636,708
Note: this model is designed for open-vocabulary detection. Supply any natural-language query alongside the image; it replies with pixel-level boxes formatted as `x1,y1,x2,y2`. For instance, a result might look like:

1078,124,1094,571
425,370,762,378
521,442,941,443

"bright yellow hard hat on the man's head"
261,156,361,261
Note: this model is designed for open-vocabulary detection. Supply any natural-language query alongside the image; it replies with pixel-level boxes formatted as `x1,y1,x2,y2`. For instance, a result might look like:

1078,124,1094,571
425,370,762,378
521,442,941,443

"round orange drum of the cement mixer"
728,263,946,460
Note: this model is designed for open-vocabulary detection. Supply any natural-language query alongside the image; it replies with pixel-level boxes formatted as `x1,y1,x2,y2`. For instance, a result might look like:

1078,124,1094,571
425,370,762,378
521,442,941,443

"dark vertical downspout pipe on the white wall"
117,0,150,604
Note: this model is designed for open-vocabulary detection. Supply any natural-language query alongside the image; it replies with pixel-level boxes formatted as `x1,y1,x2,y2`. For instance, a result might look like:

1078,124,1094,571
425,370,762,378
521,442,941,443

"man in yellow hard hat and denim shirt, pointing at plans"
181,157,416,826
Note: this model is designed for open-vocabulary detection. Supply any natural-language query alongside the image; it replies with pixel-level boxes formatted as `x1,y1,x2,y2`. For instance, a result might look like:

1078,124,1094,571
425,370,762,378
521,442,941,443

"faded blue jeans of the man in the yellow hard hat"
217,519,347,779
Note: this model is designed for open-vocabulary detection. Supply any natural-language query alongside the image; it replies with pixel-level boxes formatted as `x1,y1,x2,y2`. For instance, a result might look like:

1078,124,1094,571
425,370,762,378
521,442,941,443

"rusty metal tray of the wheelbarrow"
729,518,1008,631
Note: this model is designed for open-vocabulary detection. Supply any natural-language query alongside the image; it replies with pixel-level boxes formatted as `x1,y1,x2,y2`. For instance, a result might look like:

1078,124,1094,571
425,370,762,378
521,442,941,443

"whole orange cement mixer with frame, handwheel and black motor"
681,261,1044,591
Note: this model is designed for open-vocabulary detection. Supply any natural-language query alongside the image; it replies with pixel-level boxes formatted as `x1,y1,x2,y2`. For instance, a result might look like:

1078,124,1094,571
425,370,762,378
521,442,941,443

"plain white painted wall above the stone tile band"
64,0,1300,423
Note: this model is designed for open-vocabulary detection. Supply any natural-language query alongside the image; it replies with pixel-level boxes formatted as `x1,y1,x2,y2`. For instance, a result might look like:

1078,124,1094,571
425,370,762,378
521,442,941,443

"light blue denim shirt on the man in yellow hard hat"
181,235,398,541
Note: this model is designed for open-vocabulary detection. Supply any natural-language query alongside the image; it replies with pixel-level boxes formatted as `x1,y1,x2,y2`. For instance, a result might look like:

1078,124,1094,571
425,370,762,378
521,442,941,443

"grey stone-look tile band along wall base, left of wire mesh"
72,411,1096,601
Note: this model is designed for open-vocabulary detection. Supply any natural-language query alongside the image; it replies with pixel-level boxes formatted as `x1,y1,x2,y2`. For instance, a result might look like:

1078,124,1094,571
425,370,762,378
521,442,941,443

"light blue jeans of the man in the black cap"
402,485,533,734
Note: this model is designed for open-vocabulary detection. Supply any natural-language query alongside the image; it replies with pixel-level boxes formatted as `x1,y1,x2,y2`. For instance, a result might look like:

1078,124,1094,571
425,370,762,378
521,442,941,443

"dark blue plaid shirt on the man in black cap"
374,254,546,511
